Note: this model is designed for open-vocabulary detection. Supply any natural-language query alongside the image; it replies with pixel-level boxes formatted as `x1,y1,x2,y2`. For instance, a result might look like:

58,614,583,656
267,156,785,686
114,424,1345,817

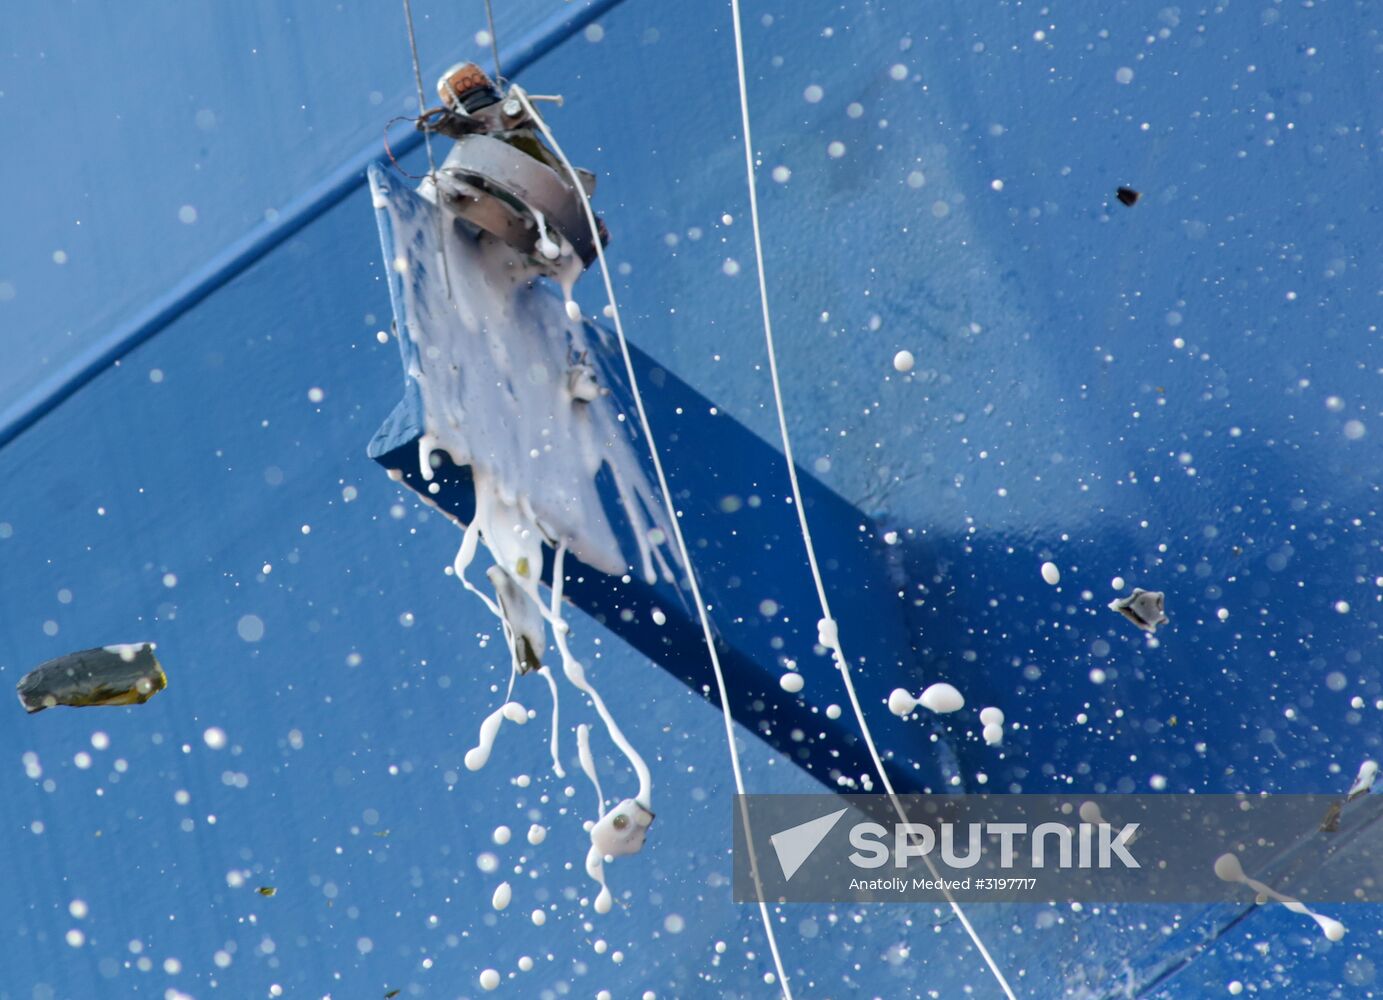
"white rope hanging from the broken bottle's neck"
510,84,792,1000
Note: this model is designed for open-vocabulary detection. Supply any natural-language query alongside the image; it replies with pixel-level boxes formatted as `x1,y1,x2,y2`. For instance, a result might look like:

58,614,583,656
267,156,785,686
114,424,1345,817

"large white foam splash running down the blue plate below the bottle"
372,170,678,913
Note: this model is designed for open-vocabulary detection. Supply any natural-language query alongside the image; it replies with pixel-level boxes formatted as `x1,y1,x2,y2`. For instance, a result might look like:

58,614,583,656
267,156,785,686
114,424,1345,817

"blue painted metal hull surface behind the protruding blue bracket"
0,1,1383,1000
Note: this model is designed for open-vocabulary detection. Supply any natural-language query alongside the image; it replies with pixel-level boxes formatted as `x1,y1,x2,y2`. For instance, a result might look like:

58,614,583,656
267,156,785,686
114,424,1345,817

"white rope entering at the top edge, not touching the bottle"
730,0,1015,1000
